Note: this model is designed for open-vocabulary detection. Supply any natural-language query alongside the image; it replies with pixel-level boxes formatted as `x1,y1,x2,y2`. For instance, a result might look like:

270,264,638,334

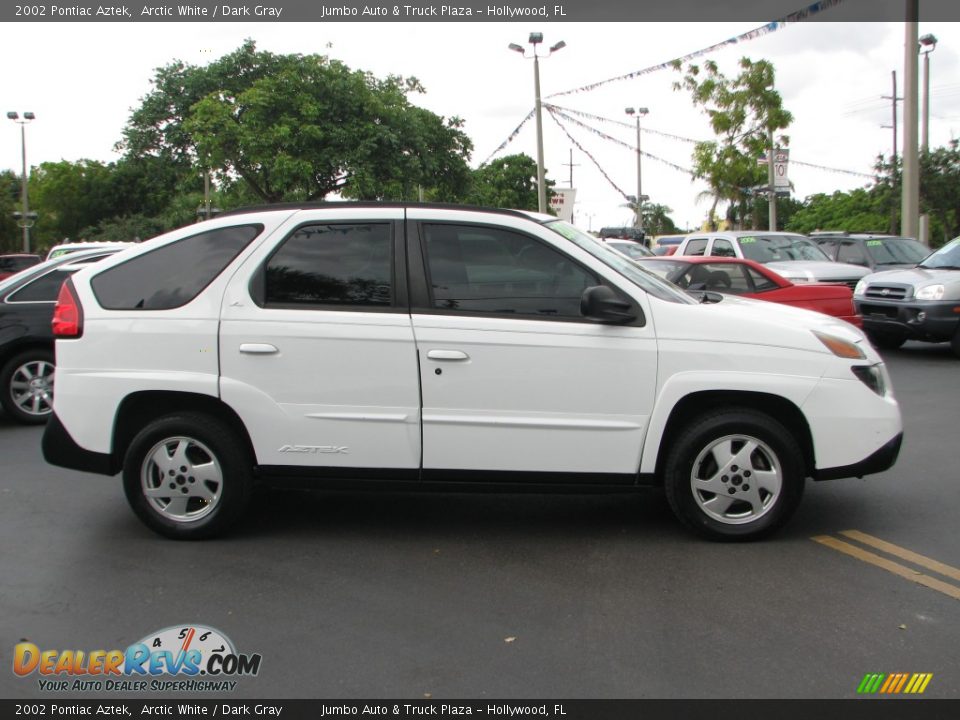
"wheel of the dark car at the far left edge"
0,348,56,425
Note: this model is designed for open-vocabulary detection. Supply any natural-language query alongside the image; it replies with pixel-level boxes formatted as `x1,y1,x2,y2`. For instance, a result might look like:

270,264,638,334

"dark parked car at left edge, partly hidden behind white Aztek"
0,250,126,423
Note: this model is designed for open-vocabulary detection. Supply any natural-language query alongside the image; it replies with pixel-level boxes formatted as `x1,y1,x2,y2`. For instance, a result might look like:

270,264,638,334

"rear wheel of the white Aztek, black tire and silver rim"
123,412,253,540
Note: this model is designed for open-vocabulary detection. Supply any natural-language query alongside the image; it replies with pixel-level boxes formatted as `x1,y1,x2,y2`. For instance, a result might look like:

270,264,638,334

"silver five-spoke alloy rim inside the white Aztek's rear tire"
140,436,223,523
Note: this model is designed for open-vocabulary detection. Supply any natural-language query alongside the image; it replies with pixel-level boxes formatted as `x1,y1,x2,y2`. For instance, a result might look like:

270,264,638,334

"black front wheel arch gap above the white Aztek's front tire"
655,390,816,484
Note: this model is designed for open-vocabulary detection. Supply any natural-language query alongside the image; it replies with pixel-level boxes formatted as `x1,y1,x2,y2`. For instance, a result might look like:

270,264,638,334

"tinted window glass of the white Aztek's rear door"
265,223,393,307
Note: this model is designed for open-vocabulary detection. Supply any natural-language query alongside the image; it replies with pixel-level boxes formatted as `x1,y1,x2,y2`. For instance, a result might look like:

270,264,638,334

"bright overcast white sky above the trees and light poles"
0,17,960,230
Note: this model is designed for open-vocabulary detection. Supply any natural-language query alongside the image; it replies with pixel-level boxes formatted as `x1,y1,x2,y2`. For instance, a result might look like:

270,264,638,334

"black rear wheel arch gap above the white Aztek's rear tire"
110,390,257,464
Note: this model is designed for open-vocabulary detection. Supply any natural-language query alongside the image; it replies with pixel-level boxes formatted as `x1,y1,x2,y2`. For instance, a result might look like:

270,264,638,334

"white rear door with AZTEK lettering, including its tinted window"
220,206,420,479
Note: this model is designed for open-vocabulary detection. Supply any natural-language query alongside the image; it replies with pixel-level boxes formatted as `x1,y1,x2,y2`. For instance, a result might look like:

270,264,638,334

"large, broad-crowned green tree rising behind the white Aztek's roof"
122,40,472,202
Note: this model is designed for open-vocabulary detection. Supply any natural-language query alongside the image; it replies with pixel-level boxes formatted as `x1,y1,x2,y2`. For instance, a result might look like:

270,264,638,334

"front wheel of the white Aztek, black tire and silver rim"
664,408,806,540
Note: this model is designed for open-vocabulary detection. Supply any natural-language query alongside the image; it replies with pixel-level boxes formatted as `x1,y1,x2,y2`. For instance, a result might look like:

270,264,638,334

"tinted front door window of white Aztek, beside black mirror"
424,225,600,318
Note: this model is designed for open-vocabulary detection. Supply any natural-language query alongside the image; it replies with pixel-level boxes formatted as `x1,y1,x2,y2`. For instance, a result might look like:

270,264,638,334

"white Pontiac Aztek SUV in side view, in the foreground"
43,203,901,539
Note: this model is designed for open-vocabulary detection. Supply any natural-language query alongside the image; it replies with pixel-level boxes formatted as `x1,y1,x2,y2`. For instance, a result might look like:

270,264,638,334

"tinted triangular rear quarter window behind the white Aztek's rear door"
90,225,263,310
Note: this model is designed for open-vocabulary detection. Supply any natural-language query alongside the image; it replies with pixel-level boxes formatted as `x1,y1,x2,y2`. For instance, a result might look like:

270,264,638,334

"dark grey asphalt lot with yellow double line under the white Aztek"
0,343,960,699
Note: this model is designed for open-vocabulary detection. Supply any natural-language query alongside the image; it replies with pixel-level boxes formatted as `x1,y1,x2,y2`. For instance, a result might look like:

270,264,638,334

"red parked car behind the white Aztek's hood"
634,255,863,328
